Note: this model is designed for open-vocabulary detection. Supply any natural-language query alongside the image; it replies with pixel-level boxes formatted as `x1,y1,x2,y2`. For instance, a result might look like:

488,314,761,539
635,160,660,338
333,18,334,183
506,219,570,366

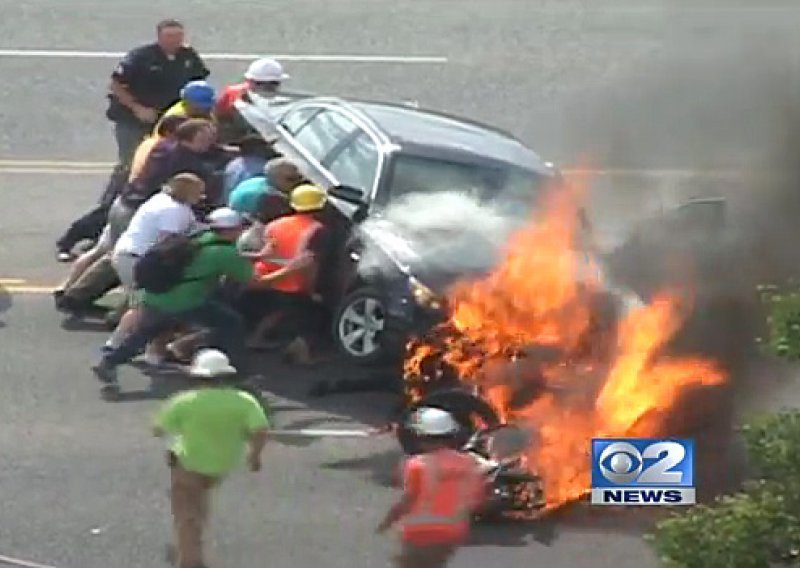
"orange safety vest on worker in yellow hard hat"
255,213,322,293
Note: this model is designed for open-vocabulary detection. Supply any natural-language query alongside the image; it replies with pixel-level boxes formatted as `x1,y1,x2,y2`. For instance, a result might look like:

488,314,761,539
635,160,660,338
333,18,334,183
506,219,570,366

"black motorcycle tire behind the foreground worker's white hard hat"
396,388,501,455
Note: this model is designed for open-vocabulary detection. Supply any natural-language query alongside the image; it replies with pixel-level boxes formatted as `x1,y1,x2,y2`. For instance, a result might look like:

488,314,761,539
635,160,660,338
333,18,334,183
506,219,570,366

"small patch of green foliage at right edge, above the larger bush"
758,284,800,361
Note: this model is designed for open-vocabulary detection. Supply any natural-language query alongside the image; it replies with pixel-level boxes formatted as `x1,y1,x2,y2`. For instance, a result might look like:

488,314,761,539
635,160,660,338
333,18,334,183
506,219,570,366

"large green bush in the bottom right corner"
647,410,800,568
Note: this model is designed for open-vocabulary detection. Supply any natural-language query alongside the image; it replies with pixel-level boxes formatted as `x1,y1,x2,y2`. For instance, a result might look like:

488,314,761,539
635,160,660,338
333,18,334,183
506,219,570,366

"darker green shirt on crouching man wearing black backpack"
142,231,253,313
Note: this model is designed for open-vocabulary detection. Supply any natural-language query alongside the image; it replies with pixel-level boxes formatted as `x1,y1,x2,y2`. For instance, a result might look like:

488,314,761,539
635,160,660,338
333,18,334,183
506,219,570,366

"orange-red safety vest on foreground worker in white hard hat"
402,450,484,544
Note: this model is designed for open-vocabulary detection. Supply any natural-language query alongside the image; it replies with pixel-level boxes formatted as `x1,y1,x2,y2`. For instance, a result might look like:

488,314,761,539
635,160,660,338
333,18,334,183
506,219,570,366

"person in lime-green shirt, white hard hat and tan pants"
154,349,269,568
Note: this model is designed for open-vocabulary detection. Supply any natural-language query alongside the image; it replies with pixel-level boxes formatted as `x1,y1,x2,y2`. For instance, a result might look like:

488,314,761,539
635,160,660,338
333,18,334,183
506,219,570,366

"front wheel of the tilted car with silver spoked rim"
332,286,389,365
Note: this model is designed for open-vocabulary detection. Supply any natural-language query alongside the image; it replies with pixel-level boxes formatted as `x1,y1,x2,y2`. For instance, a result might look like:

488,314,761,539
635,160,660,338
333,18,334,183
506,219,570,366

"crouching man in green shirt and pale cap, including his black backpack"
92,207,253,397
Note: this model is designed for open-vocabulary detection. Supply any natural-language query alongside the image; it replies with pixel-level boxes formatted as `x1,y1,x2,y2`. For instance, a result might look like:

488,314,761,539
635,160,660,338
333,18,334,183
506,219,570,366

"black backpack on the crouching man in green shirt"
133,234,229,294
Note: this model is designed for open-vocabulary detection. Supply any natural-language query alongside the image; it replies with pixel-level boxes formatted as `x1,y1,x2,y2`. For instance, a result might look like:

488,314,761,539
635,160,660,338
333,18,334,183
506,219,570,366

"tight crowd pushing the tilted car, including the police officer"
54,20,330,380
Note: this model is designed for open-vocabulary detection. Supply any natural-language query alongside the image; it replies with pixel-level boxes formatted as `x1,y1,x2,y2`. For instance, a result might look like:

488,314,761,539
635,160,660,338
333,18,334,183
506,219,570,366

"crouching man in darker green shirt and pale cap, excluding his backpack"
92,207,253,397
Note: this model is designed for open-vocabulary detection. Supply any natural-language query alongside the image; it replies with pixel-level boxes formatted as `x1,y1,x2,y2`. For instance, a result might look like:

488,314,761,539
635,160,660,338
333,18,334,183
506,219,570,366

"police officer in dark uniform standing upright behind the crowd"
56,20,210,261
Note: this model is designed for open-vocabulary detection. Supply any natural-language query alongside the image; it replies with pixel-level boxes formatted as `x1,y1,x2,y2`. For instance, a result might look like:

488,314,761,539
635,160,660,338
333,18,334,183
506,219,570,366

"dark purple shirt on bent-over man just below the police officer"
121,140,213,207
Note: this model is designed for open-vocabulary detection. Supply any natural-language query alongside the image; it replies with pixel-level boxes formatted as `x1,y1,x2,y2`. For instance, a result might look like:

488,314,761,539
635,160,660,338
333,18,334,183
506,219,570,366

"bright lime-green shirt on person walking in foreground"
155,387,269,477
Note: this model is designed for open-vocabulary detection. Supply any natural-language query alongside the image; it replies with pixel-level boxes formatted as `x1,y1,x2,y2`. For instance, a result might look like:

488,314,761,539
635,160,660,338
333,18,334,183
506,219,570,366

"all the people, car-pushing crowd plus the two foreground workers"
54,20,490,568
